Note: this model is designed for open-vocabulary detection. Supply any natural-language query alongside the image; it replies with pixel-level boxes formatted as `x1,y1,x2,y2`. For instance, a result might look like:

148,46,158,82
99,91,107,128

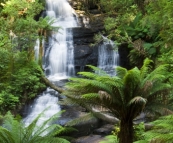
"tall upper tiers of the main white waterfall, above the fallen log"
45,0,77,80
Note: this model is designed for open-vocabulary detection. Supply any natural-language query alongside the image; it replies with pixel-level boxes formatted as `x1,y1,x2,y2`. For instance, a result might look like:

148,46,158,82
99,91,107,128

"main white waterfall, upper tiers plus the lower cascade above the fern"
24,0,77,125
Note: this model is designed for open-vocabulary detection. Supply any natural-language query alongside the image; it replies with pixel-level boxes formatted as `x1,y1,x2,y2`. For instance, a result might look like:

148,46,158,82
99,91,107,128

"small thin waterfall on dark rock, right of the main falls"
98,36,119,75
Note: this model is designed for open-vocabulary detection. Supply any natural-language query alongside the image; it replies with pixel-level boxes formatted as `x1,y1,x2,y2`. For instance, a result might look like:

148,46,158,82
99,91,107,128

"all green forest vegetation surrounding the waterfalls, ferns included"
0,0,173,143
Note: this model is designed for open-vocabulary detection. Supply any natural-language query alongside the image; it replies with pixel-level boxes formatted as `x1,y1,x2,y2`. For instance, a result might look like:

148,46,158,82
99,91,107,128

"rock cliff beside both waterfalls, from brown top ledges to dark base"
68,0,129,73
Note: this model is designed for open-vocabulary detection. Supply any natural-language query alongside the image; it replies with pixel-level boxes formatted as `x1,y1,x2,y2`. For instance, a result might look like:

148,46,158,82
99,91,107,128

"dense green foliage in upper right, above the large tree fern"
100,0,173,67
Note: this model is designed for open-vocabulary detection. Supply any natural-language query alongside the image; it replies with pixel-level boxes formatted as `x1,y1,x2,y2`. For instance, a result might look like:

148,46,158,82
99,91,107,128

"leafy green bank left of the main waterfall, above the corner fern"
0,0,59,114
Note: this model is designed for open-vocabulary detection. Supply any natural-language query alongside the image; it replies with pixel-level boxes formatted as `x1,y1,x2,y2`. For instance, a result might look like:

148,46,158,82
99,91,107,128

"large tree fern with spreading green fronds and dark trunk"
63,59,171,143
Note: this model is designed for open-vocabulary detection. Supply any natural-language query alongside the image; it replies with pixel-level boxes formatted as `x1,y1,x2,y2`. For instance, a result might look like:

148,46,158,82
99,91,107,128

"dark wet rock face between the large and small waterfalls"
73,27,98,73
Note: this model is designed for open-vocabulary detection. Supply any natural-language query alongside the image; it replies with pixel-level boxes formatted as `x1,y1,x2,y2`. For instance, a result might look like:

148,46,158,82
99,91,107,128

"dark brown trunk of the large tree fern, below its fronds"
118,118,134,143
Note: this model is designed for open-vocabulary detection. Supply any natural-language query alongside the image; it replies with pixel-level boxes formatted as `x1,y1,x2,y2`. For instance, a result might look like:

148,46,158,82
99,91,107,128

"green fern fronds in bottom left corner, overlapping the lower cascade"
0,112,69,143
